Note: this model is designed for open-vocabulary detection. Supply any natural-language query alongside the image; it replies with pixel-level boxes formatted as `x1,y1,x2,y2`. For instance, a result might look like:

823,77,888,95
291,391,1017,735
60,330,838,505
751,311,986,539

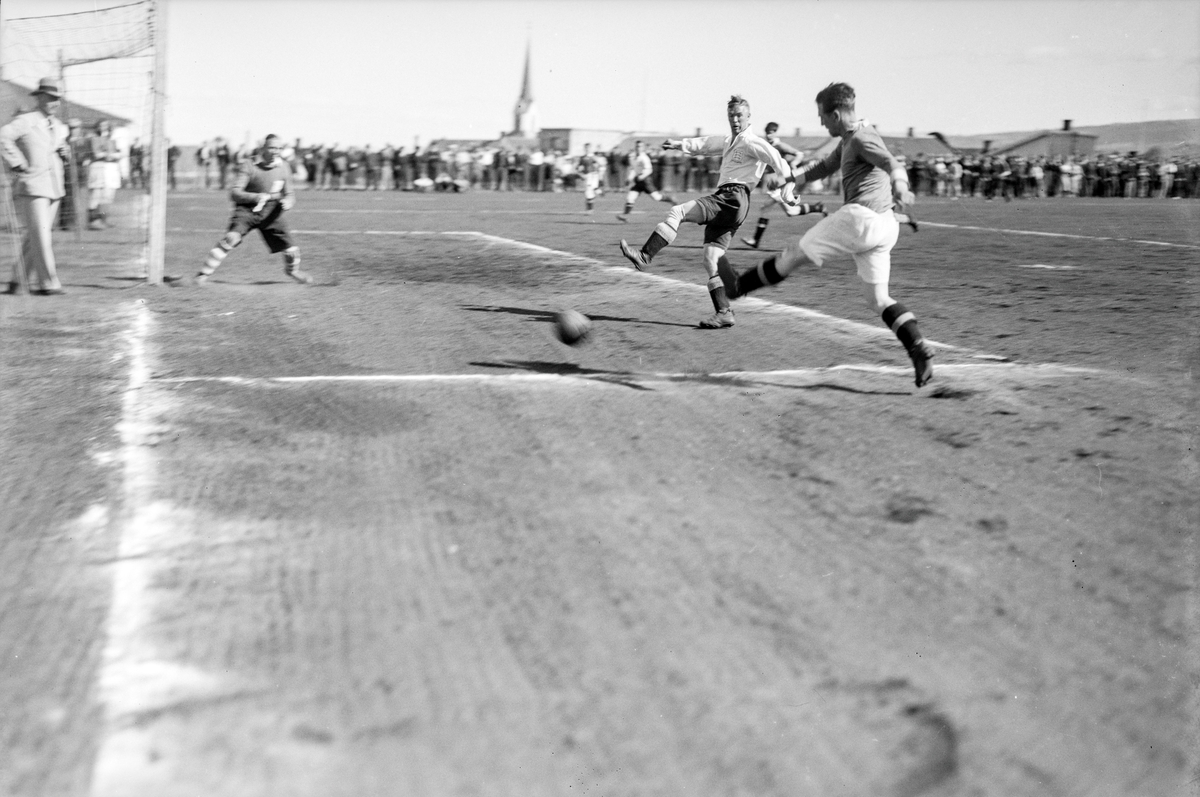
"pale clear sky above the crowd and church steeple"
0,0,1200,146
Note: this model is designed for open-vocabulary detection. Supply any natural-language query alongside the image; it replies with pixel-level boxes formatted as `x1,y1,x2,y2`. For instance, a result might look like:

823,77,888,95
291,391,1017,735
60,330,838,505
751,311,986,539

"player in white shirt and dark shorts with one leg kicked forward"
620,95,796,329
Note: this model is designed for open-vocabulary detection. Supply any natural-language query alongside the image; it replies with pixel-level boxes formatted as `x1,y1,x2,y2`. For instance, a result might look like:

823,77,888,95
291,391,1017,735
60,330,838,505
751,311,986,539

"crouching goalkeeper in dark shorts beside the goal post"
186,136,312,284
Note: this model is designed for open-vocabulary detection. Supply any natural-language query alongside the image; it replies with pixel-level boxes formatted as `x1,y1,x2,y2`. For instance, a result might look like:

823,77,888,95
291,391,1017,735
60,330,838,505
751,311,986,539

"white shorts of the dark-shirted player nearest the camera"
800,204,900,284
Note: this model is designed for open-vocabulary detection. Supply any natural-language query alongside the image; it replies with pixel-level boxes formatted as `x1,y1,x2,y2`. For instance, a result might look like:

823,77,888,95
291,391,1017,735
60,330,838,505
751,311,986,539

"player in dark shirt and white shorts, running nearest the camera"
720,83,934,388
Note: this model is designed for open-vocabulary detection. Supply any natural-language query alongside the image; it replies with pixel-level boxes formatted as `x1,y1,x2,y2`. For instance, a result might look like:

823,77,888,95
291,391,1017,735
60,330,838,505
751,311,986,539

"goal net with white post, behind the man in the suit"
0,0,167,282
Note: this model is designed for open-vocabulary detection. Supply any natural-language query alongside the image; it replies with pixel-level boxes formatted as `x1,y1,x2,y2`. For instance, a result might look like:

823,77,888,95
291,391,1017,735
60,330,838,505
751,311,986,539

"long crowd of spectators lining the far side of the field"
182,138,1200,199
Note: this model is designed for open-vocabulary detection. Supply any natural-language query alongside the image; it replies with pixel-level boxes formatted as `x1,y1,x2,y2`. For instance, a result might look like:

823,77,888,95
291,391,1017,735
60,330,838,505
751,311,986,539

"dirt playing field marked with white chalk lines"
0,192,1200,797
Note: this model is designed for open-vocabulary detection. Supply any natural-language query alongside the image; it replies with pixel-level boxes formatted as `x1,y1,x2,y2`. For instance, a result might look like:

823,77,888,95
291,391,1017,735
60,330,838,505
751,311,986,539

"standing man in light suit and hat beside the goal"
0,78,68,296
